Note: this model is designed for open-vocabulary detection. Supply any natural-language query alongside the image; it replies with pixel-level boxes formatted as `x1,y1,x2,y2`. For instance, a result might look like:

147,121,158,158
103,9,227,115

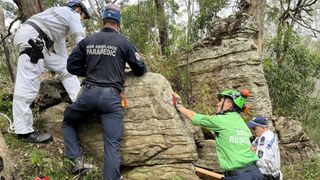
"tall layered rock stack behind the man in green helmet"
179,14,272,116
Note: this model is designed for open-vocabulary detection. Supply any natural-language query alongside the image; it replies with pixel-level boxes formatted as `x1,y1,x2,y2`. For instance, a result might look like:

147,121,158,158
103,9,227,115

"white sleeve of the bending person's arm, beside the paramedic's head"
69,12,86,43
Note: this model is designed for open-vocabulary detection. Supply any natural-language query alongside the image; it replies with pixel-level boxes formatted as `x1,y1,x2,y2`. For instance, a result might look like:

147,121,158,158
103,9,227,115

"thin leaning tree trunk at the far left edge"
0,5,15,82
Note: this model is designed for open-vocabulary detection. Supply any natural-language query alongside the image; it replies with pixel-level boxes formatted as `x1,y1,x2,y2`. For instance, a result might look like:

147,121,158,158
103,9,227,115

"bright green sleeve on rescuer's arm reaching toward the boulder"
192,114,223,131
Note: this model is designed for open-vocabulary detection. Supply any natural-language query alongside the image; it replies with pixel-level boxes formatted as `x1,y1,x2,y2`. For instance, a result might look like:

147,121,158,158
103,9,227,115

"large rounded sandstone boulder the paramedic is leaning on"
38,73,198,179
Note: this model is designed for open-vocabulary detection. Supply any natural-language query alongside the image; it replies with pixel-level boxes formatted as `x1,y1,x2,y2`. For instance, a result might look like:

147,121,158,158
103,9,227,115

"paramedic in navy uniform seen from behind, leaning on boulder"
62,3,147,180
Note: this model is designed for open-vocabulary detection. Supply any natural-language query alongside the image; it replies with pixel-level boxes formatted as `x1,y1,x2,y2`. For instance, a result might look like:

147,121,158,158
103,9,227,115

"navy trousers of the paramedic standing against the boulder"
62,84,123,180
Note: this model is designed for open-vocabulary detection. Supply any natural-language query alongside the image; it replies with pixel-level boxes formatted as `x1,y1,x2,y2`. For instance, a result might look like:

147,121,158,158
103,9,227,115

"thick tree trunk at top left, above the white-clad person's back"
14,0,43,22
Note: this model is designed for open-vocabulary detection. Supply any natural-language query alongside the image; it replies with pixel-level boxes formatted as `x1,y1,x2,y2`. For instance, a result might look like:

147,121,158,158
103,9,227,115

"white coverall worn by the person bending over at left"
13,7,85,134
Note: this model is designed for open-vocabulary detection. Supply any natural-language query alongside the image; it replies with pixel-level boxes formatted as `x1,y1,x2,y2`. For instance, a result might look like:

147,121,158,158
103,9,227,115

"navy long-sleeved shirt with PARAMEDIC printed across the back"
67,28,147,91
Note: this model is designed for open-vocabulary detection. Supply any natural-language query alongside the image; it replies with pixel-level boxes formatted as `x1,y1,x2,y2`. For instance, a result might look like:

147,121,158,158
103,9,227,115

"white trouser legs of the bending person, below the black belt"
12,24,80,134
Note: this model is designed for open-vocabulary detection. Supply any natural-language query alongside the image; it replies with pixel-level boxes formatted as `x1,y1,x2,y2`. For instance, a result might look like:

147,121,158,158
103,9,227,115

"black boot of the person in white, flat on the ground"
18,132,53,143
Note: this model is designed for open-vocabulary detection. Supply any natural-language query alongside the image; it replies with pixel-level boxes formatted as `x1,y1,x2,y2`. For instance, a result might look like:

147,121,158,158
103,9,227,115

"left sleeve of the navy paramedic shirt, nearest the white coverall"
67,40,87,76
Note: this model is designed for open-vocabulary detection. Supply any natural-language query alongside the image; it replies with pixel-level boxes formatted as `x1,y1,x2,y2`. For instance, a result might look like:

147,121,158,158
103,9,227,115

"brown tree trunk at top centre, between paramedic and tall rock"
155,0,168,56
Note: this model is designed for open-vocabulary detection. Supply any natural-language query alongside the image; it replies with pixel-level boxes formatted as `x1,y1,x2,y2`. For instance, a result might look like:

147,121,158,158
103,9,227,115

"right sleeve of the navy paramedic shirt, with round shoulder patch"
126,42,148,76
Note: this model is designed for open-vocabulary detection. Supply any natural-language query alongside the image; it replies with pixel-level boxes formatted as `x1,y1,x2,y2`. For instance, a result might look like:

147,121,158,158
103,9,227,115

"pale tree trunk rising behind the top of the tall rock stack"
241,0,266,55
